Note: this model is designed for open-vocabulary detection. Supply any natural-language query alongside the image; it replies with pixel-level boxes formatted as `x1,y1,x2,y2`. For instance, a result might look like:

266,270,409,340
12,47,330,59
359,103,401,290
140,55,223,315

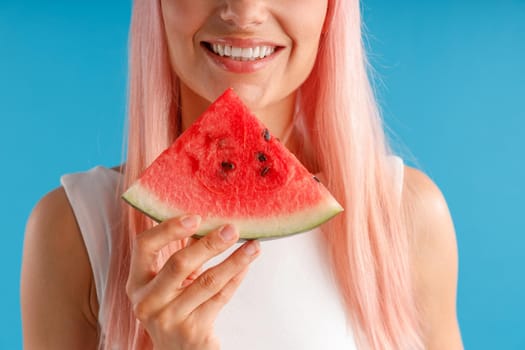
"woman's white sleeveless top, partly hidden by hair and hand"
61,156,404,350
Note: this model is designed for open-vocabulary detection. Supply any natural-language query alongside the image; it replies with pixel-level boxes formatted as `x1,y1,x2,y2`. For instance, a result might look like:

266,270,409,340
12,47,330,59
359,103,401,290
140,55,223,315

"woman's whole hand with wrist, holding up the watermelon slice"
126,216,259,350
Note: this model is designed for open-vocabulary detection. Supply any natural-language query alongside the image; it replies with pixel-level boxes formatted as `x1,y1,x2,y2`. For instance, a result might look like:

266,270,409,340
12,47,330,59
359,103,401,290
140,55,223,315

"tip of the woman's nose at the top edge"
221,0,267,29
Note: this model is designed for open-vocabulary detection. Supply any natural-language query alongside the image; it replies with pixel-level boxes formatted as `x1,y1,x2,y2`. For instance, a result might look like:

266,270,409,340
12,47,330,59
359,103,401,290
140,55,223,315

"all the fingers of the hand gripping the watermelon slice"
126,216,259,334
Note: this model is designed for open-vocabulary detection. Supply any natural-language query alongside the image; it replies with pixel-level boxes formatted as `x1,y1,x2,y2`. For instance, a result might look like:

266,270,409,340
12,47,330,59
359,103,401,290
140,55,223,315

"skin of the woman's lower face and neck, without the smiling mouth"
161,0,327,142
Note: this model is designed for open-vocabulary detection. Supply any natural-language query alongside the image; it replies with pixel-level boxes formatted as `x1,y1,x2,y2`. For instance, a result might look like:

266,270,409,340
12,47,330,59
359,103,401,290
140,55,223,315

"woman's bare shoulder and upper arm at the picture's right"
402,167,463,350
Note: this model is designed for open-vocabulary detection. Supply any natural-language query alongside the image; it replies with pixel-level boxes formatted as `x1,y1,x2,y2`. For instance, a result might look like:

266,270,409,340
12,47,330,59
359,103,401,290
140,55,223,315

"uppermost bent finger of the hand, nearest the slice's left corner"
126,215,201,297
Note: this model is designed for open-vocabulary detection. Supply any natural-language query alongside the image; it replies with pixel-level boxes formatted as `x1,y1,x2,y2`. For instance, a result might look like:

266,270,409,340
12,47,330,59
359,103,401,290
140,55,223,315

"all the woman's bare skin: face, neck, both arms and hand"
21,0,462,350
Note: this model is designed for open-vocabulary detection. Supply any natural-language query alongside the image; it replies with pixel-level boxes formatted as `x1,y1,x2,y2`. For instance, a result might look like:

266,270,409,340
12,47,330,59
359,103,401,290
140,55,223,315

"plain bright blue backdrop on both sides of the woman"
0,0,525,349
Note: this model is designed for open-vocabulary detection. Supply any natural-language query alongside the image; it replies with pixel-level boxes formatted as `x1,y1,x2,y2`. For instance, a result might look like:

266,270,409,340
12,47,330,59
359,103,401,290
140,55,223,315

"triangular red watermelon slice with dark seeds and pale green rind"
122,89,343,239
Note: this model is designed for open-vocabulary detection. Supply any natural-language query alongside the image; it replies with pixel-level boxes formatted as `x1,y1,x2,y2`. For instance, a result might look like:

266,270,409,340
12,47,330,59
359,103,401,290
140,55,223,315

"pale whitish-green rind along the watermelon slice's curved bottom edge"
122,182,343,239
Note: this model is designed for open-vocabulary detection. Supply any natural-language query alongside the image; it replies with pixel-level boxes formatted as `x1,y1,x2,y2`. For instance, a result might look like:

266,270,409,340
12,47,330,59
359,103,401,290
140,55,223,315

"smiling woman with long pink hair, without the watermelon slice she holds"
22,0,462,349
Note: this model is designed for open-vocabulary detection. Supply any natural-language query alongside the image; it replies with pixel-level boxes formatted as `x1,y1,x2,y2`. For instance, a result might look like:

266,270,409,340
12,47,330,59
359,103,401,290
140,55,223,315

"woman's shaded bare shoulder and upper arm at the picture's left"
21,188,98,349
